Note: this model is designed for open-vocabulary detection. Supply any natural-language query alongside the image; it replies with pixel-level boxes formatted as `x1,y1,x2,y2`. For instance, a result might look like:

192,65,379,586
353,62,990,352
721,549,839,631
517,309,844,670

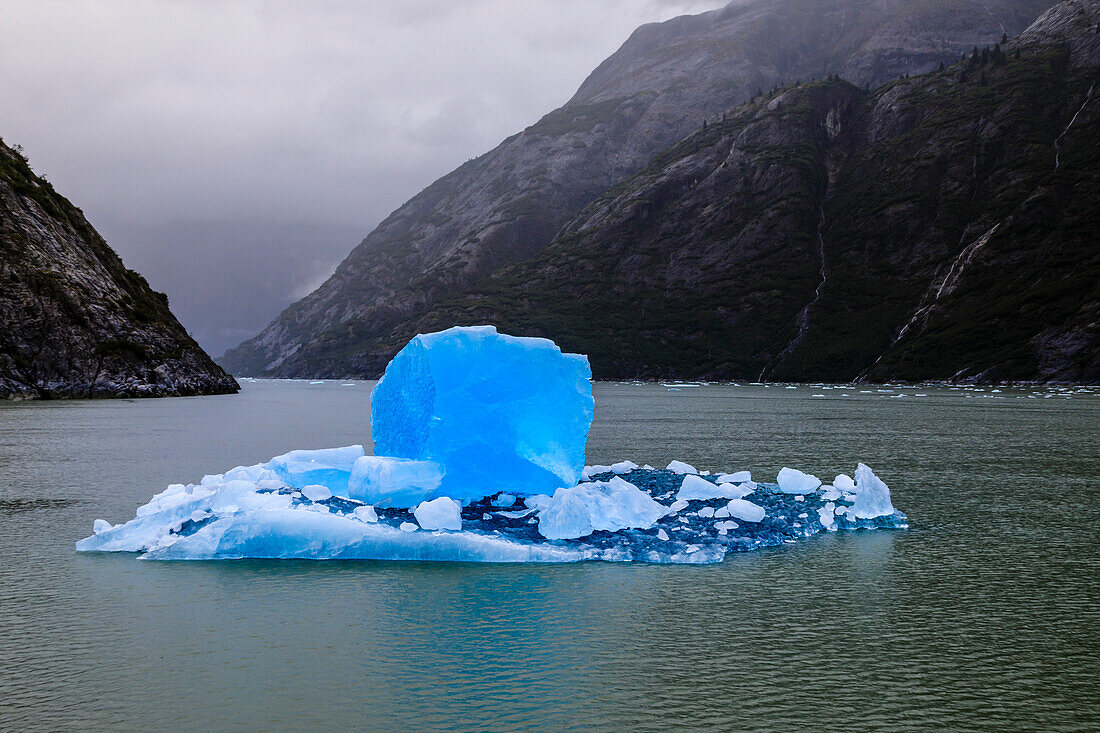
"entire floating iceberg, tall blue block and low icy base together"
76,326,908,564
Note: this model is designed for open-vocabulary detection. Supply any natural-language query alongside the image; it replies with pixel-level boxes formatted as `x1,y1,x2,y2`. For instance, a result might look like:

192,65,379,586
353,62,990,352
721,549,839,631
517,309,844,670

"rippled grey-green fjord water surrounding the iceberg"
0,382,1100,731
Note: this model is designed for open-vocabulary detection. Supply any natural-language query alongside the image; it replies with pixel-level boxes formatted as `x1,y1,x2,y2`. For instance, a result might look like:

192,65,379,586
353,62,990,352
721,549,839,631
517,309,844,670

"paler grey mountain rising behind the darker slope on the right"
220,0,1051,376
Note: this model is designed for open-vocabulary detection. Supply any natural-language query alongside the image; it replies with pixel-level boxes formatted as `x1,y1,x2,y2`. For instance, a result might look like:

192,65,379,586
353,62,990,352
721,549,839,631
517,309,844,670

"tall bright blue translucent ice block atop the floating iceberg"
371,326,595,500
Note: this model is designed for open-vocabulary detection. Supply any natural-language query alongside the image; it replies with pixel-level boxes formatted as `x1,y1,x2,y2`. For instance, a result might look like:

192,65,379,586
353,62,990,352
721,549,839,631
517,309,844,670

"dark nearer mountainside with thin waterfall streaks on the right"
404,0,1100,382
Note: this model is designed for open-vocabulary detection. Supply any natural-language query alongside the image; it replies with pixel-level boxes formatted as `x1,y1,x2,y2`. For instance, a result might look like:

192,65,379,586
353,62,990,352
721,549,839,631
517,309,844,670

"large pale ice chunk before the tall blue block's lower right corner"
539,477,668,539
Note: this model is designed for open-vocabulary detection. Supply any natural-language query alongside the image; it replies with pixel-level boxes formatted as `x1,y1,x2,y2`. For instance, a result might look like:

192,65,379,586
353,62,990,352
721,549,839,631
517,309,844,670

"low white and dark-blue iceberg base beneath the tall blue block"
76,464,908,564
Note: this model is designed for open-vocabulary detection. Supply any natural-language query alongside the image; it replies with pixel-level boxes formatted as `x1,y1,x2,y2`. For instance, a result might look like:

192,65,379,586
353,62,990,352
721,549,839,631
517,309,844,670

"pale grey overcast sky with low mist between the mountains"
0,0,725,354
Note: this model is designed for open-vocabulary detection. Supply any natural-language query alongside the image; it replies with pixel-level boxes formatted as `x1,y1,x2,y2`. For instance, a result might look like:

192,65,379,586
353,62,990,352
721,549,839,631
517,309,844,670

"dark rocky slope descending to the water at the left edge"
0,141,240,398
